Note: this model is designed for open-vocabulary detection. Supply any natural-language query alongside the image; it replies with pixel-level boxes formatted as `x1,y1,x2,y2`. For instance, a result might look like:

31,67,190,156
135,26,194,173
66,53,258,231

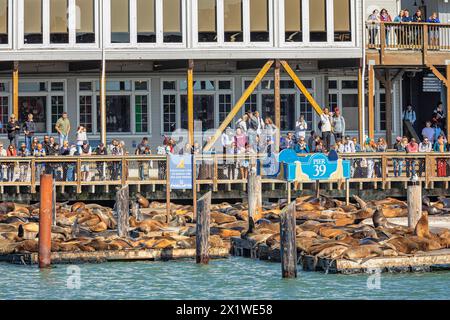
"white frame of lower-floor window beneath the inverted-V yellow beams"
243,76,317,134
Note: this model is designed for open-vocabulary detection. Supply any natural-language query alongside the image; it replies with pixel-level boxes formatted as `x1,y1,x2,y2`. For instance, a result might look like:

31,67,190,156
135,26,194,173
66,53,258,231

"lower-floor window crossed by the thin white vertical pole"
78,80,150,134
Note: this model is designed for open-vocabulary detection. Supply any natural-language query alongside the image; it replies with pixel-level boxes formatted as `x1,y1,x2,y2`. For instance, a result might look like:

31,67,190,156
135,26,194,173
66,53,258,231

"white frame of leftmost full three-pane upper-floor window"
17,0,100,49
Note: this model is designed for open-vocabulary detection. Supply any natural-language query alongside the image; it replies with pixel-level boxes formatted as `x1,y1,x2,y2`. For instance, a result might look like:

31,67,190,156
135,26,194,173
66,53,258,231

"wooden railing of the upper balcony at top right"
366,21,450,52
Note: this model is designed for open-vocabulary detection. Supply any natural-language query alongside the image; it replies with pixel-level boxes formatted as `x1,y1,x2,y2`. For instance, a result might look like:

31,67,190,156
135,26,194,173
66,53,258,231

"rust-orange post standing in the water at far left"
39,174,53,268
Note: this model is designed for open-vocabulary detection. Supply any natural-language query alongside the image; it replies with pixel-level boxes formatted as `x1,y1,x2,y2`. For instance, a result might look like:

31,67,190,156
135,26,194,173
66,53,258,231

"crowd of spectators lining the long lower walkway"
0,103,448,181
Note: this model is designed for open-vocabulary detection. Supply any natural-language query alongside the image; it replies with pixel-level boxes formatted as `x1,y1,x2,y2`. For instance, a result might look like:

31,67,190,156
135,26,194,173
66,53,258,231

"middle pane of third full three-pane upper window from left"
224,0,244,42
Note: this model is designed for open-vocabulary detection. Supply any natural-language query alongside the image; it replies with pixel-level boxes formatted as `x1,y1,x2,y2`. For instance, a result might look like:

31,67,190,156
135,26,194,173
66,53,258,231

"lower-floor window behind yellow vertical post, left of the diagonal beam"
162,79,233,132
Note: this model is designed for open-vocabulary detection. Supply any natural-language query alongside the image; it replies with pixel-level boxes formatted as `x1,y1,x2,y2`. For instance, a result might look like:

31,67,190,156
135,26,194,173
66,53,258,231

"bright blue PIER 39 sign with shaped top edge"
280,150,351,182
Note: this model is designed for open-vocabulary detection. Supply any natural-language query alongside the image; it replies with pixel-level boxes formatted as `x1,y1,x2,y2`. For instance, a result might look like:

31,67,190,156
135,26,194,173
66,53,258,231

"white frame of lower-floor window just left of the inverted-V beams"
160,76,235,135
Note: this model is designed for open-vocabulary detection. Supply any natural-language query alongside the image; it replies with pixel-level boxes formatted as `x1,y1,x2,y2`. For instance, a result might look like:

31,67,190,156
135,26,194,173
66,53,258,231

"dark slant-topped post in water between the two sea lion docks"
195,191,211,264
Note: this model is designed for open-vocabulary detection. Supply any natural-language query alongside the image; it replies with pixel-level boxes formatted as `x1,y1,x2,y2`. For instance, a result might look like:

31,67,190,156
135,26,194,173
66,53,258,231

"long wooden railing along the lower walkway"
0,152,450,193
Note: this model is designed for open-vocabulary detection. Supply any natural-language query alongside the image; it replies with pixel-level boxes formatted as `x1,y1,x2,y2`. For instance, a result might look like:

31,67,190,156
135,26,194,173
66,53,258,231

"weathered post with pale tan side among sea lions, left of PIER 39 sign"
247,158,262,233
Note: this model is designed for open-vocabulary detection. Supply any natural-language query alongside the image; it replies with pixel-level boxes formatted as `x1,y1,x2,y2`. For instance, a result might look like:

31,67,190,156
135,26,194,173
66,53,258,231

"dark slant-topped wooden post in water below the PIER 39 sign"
280,201,297,278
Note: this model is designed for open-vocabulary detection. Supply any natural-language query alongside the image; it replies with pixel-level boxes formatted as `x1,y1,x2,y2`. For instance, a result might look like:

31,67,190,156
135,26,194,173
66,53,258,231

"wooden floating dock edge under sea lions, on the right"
231,238,450,274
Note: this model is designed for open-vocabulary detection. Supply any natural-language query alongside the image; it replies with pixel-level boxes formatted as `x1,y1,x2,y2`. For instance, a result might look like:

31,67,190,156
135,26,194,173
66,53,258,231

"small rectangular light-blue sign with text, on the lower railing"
169,154,192,190
